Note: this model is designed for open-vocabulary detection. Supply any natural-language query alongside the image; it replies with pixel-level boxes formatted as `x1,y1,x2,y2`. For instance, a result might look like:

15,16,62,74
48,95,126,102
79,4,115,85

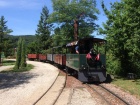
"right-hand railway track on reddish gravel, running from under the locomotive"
87,84,130,105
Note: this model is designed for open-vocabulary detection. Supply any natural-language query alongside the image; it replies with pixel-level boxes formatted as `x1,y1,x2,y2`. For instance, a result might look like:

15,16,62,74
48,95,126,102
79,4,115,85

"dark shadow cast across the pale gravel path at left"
0,72,37,89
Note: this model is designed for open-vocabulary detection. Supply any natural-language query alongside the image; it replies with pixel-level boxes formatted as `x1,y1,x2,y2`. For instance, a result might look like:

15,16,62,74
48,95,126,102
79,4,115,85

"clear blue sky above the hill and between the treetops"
0,0,120,35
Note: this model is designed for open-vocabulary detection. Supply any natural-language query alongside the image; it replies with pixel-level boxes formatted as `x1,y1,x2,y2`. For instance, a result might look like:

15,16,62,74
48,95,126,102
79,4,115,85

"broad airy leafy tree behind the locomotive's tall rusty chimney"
48,0,99,44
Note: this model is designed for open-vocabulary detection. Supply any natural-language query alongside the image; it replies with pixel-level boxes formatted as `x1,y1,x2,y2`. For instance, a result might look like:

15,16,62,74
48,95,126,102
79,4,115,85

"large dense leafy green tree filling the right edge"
101,0,140,75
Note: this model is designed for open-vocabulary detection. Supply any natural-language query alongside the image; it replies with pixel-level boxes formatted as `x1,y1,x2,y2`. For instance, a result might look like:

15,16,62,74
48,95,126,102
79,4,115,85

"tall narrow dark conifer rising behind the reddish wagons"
36,6,51,51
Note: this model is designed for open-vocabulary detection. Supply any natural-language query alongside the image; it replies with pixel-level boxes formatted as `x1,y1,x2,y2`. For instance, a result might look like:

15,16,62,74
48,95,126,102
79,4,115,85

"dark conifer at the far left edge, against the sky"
0,16,12,64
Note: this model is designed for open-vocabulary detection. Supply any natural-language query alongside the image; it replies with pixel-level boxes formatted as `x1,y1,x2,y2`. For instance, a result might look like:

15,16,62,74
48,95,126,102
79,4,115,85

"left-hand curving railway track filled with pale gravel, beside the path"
33,69,67,105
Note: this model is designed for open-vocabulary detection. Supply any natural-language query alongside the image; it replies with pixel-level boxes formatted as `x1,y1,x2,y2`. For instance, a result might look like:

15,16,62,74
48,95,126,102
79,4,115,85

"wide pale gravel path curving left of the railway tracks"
0,61,59,105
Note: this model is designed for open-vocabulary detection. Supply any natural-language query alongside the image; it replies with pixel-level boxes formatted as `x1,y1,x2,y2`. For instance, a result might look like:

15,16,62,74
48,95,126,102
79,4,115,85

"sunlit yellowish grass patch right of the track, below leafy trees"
112,78,140,98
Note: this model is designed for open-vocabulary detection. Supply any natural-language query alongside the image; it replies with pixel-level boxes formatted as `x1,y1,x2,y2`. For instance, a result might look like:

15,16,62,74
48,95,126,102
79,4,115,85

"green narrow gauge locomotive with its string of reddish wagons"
28,37,106,82
